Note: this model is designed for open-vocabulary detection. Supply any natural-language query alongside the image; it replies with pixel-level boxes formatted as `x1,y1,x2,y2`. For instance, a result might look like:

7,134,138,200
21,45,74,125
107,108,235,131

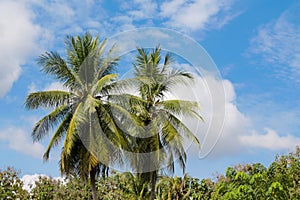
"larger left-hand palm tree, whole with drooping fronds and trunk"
25,33,126,199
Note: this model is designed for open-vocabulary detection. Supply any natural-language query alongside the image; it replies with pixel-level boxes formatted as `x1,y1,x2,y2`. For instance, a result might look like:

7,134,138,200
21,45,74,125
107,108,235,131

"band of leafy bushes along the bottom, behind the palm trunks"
0,147,300,200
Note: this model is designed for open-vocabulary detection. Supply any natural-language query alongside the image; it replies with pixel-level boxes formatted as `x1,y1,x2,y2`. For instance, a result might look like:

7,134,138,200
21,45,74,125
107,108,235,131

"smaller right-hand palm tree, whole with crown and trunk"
116,47,202,199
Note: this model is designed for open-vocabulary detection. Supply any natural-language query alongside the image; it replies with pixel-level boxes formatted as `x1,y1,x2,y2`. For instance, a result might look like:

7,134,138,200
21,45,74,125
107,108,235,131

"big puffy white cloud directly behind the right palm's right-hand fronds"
176,77,250,158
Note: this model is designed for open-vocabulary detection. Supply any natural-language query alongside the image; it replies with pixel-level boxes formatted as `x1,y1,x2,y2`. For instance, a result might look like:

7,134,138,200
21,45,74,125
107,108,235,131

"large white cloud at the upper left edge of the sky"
0,0,41,98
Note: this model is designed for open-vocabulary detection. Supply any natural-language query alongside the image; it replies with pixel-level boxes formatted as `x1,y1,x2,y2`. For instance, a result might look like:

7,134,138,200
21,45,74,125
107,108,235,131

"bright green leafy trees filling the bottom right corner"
212,147,300,199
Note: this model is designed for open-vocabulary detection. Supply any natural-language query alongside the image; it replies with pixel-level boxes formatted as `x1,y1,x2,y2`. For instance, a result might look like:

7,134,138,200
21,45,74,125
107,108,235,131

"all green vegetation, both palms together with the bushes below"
8,33,300,200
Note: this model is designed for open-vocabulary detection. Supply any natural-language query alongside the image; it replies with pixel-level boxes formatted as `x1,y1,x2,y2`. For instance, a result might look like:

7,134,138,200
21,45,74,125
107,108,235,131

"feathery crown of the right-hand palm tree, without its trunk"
132,47,202,171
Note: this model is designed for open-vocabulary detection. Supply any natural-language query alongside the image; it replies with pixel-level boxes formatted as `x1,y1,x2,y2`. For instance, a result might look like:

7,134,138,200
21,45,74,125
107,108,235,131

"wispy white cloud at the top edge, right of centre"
160,0,237,31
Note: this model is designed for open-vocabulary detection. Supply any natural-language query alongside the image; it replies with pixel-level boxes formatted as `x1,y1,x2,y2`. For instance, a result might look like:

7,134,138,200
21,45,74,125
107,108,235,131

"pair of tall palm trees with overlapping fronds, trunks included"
24,33,202,200
